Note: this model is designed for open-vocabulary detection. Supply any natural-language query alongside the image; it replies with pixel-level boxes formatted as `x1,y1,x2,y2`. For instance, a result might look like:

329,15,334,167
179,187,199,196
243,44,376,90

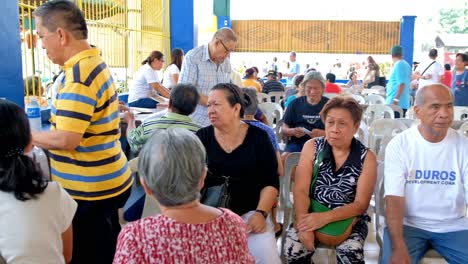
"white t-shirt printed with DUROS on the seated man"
384,126,468,233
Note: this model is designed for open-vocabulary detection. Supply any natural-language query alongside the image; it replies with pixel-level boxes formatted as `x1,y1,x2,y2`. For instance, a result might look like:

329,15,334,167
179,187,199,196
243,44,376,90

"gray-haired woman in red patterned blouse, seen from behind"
114,128,254,263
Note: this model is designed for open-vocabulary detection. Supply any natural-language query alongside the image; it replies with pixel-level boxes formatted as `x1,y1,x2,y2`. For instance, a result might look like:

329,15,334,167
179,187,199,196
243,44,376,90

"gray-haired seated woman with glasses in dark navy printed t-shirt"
282,72,328,156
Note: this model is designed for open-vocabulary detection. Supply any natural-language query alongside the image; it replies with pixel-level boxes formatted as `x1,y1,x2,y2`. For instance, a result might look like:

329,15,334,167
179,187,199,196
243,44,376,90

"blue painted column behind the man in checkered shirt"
170,0,198,53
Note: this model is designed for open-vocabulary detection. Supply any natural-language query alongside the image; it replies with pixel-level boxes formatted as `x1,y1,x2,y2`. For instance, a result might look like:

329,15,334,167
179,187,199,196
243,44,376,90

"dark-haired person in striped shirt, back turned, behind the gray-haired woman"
124,84,201,153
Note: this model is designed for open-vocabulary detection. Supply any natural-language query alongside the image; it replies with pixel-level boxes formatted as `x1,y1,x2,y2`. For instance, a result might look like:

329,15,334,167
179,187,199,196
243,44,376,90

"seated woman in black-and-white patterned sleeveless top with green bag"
285,97,377,263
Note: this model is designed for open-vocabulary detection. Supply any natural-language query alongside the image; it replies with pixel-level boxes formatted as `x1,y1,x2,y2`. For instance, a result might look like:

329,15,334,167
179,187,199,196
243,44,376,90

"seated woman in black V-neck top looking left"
197,83,281,264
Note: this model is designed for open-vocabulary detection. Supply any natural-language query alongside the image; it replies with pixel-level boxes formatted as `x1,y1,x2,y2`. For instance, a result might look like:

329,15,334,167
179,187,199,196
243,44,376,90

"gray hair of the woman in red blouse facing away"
138,128,206,206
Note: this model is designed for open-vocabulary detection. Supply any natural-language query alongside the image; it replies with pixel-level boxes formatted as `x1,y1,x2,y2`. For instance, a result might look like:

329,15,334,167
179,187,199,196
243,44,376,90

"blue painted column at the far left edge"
0,1,24,107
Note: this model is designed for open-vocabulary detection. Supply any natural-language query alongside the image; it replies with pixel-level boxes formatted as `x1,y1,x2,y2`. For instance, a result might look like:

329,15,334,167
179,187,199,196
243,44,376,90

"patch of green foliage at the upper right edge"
439,7,468,34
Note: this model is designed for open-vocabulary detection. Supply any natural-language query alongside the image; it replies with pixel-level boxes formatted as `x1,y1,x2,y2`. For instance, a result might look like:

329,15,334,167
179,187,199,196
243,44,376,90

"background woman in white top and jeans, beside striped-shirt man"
128,50,170,108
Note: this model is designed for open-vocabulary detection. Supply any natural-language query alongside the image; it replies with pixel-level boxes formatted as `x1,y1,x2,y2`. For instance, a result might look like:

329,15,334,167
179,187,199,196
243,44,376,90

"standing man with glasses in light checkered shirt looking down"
179,27,237,127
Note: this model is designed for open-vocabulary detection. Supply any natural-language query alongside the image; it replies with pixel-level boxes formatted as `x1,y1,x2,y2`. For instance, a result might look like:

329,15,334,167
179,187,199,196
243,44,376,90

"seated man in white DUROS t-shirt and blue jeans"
382,84,468,263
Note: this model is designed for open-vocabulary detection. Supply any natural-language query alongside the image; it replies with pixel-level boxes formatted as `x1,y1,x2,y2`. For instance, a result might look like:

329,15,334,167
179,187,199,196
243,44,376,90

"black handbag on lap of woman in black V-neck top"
200,176,231,208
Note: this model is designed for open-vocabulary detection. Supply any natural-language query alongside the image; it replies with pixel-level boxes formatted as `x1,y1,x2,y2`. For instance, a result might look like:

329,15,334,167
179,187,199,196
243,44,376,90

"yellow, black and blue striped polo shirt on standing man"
50,49,133,200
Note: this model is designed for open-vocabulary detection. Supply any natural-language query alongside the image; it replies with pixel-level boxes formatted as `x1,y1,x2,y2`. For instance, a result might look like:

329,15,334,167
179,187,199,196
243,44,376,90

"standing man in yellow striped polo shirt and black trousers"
33,0,133,263
